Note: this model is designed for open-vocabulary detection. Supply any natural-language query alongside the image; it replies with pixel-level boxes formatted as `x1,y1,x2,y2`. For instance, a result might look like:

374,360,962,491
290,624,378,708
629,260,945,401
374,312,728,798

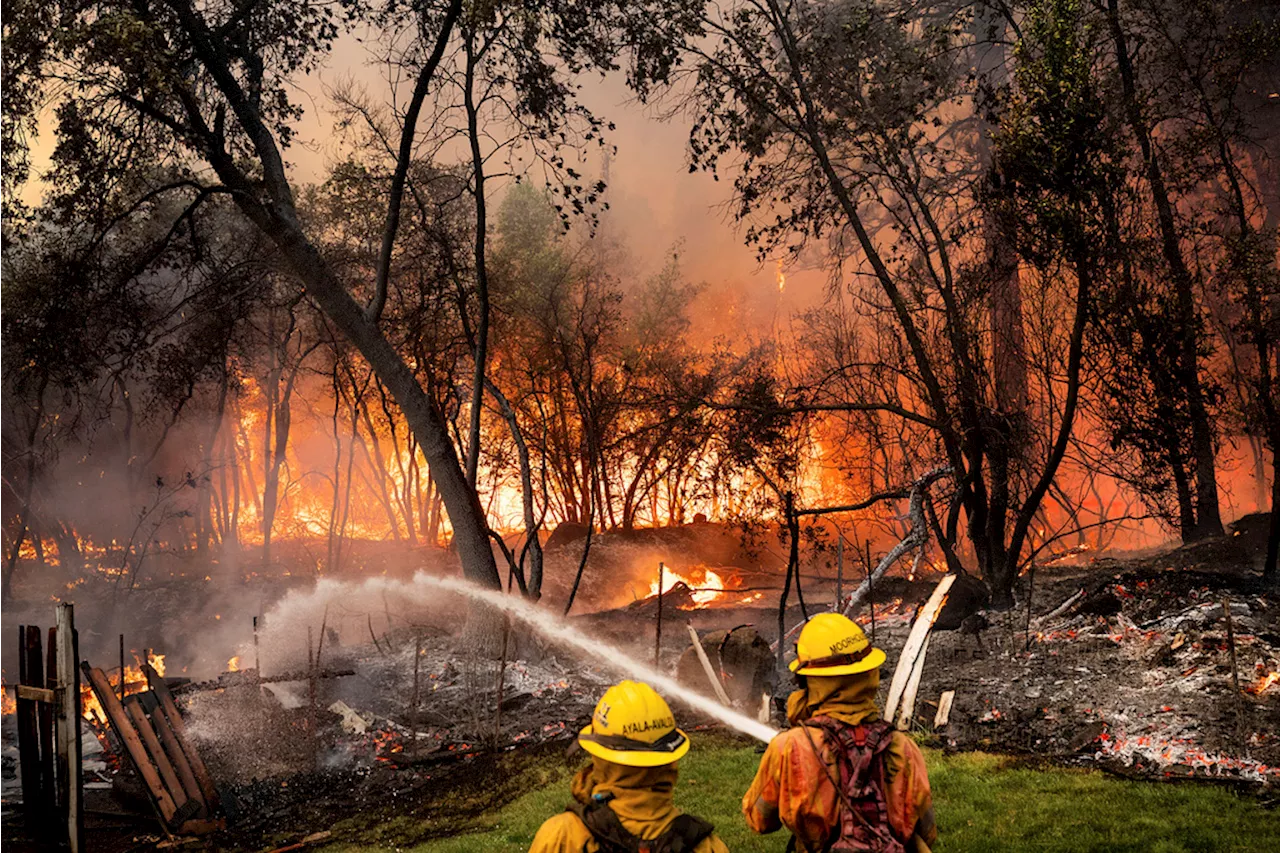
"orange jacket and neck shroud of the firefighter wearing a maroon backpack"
742,670,937,853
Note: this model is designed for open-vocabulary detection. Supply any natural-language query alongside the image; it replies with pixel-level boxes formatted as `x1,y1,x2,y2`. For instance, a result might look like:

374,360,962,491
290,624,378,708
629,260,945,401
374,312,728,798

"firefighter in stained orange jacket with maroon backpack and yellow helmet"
742,613,938,853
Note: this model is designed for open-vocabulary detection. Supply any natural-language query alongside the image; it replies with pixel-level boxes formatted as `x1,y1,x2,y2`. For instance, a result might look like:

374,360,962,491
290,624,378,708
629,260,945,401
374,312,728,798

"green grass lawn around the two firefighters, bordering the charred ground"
326,738,1280,853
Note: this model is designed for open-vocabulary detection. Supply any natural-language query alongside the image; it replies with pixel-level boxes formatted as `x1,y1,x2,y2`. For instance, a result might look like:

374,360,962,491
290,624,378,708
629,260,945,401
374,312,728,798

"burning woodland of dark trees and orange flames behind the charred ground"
0,0,1280,605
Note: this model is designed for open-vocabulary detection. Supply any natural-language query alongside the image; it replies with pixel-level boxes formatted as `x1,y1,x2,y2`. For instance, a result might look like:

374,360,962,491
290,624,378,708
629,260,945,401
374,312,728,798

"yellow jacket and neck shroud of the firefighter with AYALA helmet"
529,758,728,853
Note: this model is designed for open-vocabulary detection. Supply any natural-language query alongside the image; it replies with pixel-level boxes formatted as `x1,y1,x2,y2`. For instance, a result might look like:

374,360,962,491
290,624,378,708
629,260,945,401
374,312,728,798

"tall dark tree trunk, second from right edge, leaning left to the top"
1107,0,1222,539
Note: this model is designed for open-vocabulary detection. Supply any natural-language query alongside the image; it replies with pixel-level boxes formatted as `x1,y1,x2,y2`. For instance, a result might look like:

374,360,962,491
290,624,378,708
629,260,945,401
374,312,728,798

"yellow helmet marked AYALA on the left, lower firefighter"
577,681,689,767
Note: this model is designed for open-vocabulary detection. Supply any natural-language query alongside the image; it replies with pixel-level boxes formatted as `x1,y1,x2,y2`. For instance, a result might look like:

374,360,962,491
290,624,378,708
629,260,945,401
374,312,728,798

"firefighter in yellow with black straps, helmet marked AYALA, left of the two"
529,681,728,853
